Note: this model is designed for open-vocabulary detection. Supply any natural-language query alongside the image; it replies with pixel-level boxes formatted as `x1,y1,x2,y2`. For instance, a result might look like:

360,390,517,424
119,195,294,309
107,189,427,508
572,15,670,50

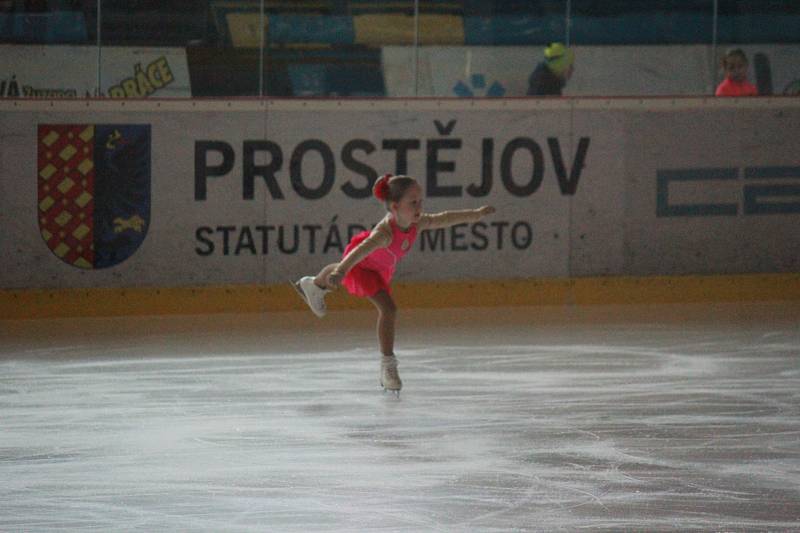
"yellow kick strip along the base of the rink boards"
0,274,800,319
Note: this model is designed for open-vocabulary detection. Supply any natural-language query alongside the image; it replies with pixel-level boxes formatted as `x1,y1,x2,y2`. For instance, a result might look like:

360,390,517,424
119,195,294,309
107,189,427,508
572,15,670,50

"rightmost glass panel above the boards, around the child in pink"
716,0,800,96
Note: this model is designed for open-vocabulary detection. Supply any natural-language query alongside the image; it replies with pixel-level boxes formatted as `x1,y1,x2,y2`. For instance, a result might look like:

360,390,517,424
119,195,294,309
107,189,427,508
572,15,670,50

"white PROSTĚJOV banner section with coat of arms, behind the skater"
0,100,608,287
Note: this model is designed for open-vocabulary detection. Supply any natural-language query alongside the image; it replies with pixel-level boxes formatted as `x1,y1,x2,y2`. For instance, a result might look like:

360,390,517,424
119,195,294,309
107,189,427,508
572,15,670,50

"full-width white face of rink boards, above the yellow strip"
0,98,800,288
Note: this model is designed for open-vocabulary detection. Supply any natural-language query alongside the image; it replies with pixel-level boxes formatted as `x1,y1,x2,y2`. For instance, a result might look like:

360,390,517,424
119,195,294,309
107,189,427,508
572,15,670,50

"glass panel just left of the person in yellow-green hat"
418,0,567,98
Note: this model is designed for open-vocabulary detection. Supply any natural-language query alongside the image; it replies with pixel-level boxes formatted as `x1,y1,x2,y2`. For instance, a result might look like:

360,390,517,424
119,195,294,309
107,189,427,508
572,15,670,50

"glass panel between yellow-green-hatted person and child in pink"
564,0,715,96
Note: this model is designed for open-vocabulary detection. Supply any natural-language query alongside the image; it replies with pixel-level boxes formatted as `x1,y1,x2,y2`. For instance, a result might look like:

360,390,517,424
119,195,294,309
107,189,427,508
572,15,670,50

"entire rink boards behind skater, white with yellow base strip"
0,97,800,314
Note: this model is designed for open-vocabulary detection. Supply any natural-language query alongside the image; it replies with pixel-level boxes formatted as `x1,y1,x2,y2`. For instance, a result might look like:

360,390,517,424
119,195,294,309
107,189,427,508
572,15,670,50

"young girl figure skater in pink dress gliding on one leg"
294,174,495,394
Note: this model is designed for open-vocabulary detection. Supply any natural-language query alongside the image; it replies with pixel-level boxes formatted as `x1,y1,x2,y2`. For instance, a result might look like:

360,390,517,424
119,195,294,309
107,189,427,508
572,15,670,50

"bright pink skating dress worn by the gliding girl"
342,219,417,298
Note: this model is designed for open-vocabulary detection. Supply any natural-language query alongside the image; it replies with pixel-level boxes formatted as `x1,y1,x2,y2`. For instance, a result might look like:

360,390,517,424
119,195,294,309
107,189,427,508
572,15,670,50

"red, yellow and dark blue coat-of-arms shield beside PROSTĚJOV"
38,124,150,269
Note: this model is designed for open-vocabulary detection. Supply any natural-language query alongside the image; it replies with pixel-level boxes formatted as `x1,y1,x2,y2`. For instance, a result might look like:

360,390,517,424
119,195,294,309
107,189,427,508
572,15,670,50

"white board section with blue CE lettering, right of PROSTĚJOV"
624,106,800,275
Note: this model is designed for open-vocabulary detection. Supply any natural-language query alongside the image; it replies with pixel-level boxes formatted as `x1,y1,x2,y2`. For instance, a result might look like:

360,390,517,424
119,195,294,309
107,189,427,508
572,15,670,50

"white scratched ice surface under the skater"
0,303,800,532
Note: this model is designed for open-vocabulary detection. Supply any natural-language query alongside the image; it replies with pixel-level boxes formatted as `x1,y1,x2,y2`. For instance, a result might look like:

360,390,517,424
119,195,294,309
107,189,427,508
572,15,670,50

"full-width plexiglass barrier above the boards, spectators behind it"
0,0,800,98
